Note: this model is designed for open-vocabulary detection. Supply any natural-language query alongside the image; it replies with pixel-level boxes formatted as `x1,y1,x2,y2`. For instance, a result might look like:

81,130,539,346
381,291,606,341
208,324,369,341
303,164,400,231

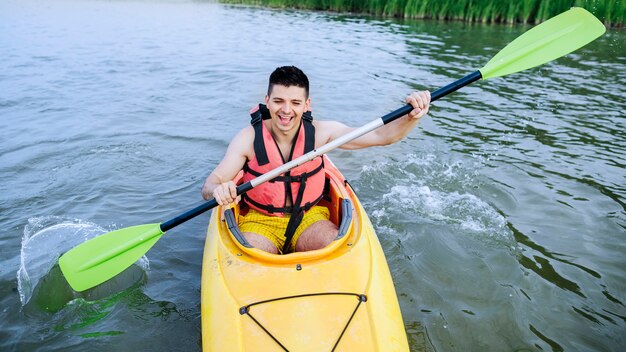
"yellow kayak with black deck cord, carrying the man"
201,156,409,352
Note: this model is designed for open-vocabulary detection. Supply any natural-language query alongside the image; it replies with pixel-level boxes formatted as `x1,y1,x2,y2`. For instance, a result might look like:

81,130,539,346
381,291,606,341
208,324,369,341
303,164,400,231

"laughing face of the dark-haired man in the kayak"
265,84,311,134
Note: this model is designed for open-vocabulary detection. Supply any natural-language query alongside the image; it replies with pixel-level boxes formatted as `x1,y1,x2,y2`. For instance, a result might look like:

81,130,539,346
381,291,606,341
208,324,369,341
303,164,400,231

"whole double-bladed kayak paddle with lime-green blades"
59,8,605,291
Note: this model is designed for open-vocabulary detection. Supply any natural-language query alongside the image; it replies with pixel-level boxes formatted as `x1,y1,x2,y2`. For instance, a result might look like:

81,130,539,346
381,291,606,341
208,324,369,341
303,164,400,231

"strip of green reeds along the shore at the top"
221,0,626,27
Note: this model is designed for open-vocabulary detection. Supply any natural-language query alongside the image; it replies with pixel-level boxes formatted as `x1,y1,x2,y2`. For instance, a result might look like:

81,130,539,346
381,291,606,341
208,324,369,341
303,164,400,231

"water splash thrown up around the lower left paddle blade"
17,216,149,312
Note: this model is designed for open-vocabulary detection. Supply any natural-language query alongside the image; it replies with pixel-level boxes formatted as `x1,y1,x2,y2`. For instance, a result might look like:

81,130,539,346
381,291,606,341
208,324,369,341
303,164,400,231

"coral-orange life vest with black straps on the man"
243,104,326,219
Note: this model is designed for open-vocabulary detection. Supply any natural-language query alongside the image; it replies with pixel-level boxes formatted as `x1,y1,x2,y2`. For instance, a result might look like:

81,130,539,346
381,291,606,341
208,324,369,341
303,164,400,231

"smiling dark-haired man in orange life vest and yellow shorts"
202,66,430,254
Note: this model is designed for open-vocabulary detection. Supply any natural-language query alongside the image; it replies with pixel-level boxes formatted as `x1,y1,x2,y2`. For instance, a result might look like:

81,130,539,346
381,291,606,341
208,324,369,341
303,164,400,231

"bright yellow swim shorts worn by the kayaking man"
239,205,330,253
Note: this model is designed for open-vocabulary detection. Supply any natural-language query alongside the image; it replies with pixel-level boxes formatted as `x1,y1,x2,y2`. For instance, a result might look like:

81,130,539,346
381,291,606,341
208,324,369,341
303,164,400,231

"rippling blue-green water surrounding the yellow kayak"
0,0,626,351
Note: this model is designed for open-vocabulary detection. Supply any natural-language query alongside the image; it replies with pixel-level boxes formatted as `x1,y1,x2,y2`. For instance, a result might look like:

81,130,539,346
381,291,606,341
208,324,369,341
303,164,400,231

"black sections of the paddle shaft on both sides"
161,71,482,232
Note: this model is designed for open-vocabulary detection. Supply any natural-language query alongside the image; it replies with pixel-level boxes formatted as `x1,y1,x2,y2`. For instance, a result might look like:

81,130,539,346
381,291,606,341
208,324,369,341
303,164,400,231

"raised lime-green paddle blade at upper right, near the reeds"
480,7,606,79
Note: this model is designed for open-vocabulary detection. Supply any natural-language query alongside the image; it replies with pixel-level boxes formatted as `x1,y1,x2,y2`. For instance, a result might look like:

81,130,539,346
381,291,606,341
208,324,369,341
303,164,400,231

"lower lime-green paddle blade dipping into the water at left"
59,224,164,292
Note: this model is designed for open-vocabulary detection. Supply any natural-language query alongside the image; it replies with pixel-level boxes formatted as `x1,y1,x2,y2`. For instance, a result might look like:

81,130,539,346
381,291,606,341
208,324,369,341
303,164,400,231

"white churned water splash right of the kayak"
359,154,517,249
